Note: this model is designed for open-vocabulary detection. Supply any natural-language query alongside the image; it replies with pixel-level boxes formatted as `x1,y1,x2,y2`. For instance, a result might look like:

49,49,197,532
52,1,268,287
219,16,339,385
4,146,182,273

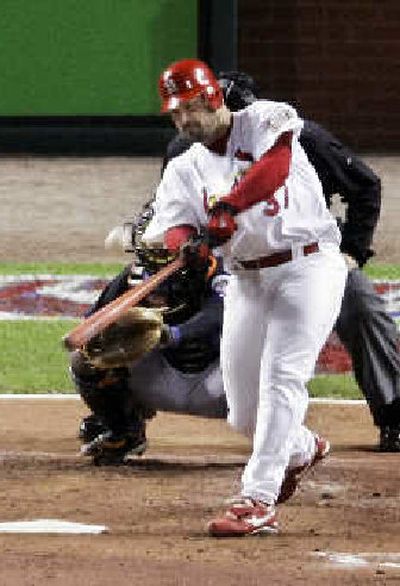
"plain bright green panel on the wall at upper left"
0,0,198,116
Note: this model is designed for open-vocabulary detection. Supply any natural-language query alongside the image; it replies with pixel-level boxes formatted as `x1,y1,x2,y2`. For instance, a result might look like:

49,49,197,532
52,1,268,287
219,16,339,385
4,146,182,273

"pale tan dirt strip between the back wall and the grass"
0,156,400,263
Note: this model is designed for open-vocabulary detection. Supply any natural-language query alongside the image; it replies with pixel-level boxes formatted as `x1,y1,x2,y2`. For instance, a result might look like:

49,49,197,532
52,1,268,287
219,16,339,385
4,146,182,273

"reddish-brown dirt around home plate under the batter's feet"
0,399,400,586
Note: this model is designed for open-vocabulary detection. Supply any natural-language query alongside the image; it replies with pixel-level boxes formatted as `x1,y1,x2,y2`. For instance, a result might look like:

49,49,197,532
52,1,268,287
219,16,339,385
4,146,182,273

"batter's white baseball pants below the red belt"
222,245,347,502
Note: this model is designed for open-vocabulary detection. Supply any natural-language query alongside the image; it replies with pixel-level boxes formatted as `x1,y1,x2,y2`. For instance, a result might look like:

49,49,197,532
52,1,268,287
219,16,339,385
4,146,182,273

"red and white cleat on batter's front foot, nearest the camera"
208,497,278,537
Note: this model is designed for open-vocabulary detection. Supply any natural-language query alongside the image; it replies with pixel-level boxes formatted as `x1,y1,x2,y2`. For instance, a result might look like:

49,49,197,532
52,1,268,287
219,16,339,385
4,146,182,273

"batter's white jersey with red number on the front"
144,100,340,267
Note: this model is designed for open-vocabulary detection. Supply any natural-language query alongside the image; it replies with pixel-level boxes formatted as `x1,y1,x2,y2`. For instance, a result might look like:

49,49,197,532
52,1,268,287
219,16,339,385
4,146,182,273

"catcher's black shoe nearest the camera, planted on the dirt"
81,421,147,466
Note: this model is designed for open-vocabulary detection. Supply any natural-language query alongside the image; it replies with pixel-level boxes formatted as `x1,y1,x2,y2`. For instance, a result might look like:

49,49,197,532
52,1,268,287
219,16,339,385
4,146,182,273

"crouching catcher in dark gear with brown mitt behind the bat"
70,202,227,464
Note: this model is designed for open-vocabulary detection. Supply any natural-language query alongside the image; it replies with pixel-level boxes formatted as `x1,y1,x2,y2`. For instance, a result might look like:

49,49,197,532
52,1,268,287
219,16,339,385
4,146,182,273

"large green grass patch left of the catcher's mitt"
0,320,78,393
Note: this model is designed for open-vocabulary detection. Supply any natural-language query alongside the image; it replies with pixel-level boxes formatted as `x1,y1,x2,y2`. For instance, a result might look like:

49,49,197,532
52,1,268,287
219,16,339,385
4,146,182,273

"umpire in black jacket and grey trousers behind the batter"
163,72,400,452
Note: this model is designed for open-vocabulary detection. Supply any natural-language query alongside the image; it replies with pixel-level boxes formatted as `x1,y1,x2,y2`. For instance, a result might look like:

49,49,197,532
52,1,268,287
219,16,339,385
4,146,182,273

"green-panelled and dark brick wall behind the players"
0,0,400,154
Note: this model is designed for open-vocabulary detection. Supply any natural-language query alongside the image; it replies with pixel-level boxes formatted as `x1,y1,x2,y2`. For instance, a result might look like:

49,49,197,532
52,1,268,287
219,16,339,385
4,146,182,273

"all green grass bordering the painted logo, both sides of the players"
0,263,400,399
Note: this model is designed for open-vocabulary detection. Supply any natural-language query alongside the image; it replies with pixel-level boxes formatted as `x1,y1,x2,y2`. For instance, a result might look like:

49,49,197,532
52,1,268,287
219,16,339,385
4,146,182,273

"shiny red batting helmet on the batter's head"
158,59,223,112
